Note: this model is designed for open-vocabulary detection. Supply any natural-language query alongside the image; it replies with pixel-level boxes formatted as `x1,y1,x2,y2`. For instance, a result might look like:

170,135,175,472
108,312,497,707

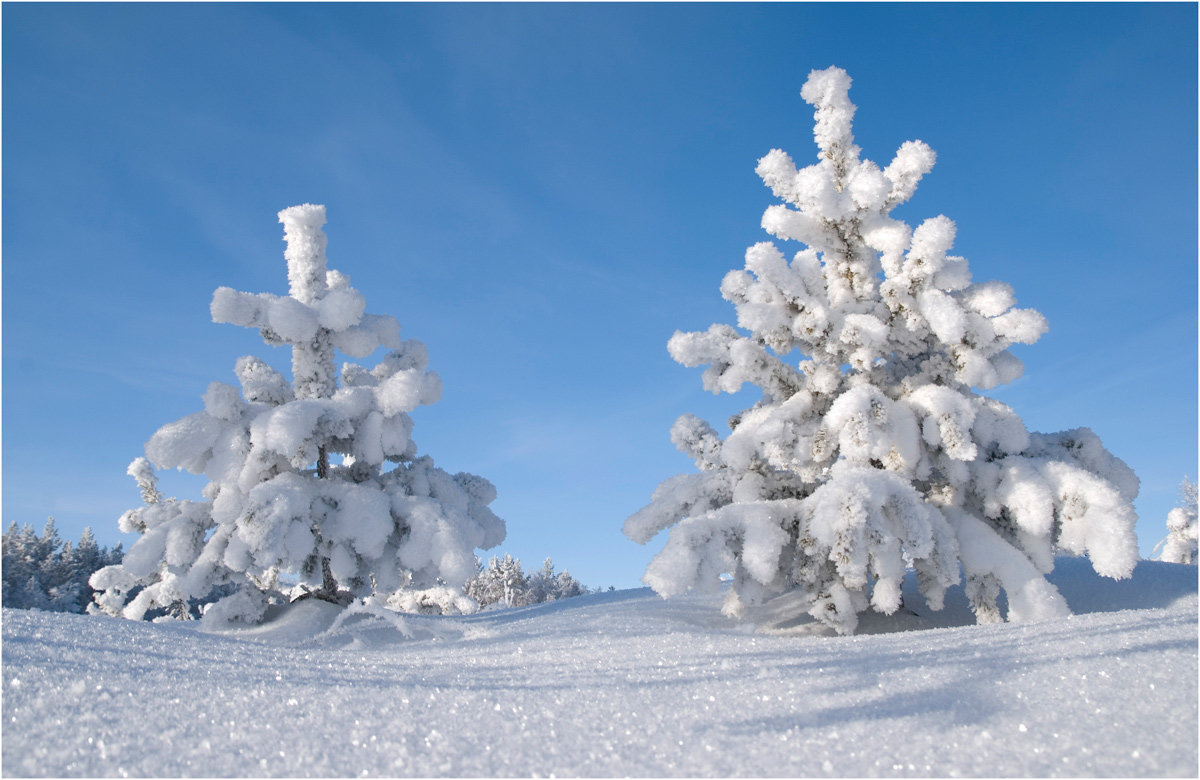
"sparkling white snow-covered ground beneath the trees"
2,559,1198,776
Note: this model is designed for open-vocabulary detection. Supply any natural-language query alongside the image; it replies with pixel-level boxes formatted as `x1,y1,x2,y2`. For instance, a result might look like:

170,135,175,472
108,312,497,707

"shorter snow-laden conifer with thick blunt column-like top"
92,204,504,620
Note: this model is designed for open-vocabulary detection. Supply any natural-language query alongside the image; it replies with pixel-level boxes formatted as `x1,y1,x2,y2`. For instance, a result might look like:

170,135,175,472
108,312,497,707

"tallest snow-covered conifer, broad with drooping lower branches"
624,67,1138,634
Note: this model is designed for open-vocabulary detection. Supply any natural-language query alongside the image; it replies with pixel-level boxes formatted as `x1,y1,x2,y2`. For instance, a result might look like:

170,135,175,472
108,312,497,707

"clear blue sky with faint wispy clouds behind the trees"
2,4,1198,587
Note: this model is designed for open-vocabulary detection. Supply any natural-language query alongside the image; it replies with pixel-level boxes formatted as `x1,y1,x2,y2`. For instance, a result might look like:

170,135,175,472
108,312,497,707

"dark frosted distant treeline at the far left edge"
0,517,124,612
